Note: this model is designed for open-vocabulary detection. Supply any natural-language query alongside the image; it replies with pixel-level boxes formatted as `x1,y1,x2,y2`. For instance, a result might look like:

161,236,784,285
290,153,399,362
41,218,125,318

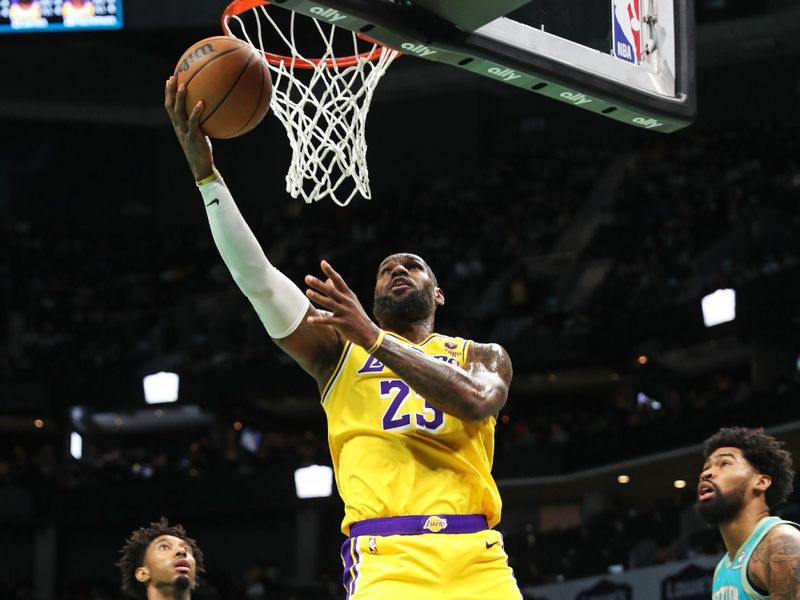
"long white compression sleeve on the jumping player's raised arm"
197,176,310,339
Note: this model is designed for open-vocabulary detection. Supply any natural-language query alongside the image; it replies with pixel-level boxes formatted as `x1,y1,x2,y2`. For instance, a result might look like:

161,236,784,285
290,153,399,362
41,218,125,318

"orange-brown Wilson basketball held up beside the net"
175,36,272,138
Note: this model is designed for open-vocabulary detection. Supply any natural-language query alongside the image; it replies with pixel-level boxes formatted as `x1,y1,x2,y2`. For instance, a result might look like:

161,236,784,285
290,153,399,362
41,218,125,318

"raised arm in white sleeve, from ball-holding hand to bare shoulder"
164,77,343,387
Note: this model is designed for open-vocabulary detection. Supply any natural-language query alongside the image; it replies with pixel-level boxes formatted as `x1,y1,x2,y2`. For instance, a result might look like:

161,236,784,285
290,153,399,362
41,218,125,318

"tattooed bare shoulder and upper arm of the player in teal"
750,529,800,600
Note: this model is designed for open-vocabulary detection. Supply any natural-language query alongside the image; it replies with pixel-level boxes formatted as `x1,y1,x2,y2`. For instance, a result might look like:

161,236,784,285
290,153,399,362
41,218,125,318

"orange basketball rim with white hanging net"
222,0,400,206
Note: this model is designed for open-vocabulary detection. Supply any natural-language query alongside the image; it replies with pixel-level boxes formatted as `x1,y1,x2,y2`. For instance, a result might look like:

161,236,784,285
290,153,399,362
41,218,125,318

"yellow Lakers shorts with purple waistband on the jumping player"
342,515,522,600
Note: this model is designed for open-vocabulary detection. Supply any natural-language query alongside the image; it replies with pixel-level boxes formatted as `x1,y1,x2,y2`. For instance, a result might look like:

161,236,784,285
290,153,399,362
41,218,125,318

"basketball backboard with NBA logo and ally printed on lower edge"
260,0,696,132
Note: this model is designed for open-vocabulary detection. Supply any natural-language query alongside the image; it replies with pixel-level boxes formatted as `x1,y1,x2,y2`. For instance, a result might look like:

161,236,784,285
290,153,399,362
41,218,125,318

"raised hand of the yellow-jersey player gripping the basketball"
164,75,214,181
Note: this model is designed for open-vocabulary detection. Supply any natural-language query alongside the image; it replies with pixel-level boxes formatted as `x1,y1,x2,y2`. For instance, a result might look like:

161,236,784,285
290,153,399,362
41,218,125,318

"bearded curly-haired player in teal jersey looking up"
697,427,800,600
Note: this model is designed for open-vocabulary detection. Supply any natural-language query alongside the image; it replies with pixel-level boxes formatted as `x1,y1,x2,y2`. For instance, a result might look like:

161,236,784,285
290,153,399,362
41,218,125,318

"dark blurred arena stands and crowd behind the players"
0,0,800,600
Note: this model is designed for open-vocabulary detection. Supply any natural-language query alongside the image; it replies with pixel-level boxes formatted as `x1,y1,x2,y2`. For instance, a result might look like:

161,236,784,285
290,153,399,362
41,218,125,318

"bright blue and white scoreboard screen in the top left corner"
0,0,122,33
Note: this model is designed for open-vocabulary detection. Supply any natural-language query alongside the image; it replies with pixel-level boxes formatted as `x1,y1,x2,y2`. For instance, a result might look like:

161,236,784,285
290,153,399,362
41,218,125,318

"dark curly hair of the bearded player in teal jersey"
703,427,794,510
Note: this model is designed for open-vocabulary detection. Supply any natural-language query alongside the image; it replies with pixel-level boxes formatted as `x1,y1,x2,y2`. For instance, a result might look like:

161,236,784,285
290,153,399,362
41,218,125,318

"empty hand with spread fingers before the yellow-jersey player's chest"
306,260,380,348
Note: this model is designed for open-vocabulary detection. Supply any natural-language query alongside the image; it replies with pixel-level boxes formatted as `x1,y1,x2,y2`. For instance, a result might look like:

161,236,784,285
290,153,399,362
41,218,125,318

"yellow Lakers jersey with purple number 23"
322,332,501,535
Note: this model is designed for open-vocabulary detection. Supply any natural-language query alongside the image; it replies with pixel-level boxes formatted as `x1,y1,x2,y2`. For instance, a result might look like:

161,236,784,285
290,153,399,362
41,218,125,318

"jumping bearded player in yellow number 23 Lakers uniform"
165,78,522,600
